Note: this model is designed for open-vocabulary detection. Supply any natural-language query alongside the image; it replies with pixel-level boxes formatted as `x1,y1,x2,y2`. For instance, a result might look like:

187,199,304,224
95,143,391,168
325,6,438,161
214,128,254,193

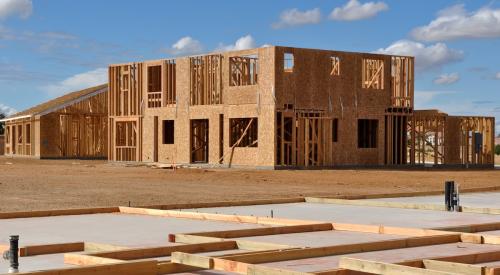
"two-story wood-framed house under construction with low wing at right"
108,46,495,169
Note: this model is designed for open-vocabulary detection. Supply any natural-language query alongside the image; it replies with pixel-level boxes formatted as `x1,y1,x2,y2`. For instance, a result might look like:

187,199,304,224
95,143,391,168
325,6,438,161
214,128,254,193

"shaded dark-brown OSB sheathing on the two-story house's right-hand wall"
276,47,391,165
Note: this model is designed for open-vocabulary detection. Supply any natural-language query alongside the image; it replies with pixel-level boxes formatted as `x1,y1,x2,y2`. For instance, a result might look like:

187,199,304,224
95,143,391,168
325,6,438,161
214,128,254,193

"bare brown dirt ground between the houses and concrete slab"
0,157,500,212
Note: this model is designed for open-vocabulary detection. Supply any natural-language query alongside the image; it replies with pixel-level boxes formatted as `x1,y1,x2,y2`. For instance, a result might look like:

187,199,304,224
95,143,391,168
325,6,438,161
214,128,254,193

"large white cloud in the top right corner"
412,4,500,41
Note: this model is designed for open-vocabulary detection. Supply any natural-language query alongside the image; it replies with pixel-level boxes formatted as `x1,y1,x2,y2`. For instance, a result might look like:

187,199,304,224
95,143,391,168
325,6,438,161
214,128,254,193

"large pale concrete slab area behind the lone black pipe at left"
0,213,270,247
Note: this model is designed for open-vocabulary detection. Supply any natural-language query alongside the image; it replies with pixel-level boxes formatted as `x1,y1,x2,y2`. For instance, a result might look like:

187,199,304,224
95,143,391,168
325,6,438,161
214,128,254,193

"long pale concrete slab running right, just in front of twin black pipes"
186,203,500,228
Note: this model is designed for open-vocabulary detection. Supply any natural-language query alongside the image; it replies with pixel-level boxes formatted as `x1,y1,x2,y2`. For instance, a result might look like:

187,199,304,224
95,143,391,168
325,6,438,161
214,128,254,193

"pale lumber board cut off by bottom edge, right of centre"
339,257,460,275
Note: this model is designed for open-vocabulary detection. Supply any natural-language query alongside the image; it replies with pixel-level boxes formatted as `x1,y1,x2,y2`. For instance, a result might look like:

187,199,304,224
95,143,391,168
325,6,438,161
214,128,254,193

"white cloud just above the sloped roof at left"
42,68,108,96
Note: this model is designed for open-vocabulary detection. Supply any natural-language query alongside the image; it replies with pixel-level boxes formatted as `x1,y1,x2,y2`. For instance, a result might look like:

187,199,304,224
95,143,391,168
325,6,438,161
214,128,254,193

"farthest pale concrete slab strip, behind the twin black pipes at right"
369,192,500,208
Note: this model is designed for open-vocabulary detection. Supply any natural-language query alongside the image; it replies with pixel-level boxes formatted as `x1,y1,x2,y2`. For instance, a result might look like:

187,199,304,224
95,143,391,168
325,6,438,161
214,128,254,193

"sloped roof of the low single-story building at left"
7,84,108,119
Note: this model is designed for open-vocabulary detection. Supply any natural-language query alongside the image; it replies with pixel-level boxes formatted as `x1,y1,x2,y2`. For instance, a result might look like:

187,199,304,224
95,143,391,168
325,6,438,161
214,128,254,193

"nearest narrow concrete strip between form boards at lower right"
263,243,500,272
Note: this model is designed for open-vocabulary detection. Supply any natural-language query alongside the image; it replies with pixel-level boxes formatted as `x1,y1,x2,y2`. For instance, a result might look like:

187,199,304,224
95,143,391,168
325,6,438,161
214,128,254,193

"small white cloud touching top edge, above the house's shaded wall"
329,0,389,21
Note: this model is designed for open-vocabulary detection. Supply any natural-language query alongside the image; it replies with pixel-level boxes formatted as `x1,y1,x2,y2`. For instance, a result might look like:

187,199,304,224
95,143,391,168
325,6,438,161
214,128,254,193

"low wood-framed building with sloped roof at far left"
2,84,108,158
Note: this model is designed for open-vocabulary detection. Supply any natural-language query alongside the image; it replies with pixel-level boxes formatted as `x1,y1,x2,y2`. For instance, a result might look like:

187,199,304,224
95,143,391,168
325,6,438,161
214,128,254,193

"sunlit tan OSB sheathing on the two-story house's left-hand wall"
143,47,275,167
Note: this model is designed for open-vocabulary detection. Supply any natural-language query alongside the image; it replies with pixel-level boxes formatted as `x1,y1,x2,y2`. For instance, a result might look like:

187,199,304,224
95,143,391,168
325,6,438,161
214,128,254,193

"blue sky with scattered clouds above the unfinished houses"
0,0,500,133
